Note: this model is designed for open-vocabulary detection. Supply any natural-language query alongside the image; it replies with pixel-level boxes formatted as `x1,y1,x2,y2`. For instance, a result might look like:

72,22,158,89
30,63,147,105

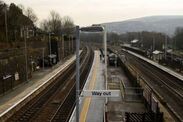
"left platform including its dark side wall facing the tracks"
0,56,76,121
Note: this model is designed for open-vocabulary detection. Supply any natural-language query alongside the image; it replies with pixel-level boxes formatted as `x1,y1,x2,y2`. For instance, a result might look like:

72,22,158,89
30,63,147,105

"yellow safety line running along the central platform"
80,52,99,122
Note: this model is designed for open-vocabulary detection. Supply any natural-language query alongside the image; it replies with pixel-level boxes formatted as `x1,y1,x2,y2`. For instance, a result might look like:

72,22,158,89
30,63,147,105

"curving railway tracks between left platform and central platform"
7,48,93,122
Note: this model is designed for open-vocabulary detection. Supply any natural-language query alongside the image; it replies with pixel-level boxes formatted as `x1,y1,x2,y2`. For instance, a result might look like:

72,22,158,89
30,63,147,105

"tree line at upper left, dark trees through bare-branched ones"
0,0,74,43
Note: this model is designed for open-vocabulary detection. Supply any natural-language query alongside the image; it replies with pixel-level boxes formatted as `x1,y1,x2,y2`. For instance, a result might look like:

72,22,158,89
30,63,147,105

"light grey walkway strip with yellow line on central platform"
70,51,105,122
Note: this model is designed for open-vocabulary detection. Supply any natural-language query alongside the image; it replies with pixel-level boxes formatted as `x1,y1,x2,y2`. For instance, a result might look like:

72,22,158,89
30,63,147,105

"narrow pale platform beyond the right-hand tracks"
123,49,183,80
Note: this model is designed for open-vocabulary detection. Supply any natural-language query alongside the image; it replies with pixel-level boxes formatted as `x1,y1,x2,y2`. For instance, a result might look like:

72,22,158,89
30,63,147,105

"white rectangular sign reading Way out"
82,90,120,97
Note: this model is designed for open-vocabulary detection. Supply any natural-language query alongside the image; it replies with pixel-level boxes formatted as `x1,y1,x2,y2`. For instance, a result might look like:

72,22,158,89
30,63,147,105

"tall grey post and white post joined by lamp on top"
76,25,107,122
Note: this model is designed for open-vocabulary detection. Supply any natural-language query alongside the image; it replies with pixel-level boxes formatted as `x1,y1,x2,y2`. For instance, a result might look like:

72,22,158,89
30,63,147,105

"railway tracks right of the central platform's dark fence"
125,53,183,121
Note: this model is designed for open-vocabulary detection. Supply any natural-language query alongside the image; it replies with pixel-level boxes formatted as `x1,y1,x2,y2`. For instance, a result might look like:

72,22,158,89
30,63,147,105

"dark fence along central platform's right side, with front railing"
117,50,163,122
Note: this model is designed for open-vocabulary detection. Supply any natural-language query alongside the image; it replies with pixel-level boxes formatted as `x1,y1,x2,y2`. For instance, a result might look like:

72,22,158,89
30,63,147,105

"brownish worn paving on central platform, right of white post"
107,66,146,122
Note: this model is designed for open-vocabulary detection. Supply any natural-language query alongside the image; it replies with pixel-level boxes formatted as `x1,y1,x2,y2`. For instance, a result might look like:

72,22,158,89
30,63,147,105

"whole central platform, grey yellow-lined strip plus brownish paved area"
69,50,146,122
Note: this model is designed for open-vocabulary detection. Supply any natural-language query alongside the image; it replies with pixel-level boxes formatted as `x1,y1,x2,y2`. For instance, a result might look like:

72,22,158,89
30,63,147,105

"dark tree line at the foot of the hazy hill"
108,27,183,50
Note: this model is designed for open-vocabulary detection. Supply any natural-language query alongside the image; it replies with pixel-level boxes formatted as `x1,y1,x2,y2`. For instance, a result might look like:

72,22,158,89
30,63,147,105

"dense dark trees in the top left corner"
0,1,34,42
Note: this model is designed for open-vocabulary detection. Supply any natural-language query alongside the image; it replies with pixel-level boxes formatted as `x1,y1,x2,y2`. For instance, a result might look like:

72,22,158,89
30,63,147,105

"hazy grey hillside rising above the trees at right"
103,16,183,35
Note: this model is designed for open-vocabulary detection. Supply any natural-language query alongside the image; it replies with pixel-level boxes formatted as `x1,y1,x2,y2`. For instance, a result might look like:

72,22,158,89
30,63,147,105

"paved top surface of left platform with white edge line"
0,56,75,117
